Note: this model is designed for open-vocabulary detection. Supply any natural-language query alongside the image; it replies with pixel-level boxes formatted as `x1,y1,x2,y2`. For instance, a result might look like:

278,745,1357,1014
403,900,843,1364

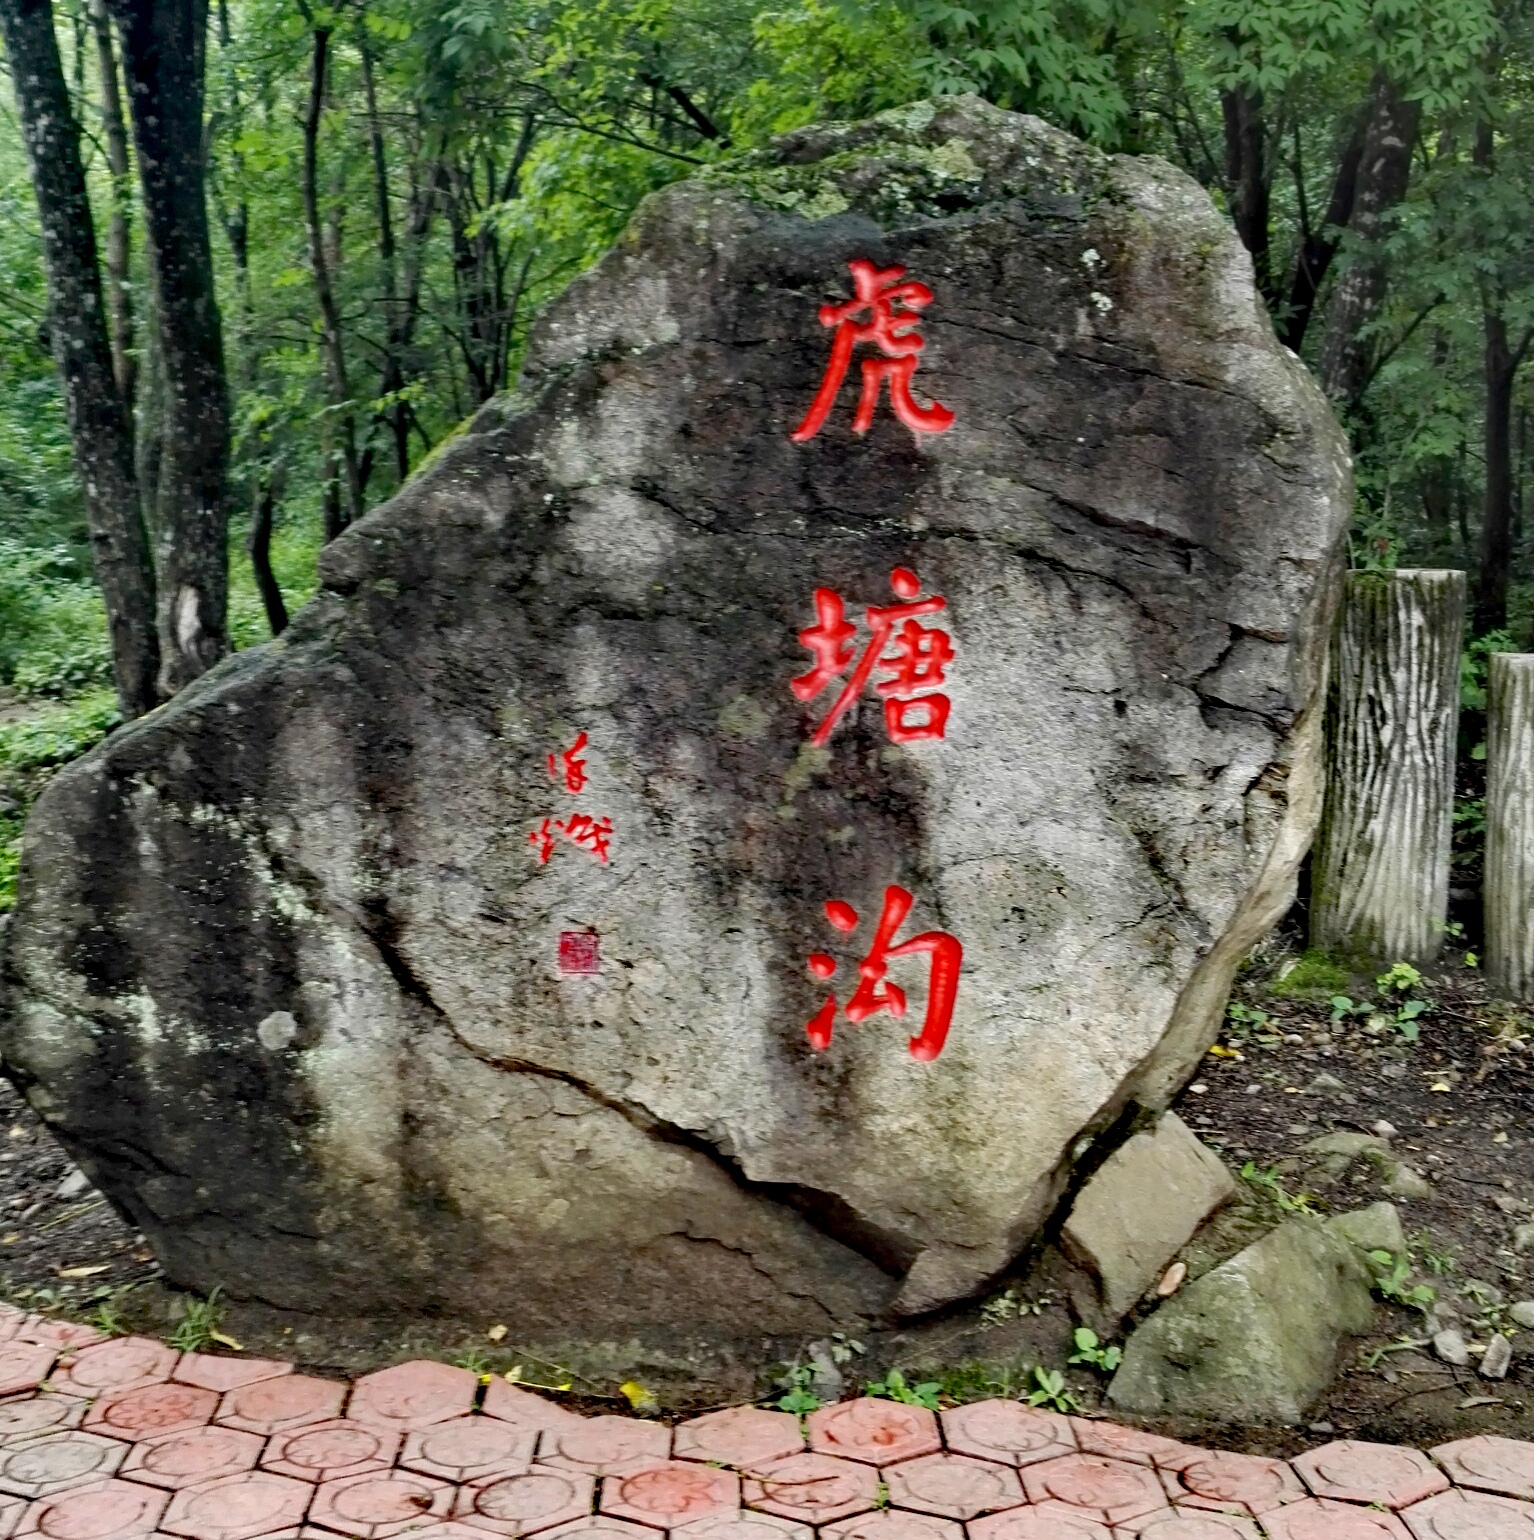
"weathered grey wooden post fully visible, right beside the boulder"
1311,570,1465,963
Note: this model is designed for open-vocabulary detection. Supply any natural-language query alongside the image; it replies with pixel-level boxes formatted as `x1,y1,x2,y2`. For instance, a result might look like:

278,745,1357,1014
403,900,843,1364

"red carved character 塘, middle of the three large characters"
789,567,953,748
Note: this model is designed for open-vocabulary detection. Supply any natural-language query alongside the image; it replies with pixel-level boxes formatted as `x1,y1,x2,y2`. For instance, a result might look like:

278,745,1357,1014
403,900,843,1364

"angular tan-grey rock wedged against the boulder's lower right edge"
1060,1112,1237,1329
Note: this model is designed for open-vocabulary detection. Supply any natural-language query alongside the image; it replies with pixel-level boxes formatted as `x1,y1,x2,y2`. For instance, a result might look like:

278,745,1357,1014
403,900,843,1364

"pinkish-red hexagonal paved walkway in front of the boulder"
0,1306,1534,1540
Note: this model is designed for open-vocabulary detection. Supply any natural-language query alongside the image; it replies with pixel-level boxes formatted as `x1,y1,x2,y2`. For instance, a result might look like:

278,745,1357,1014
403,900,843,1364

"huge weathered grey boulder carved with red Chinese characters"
3,99,1349,1332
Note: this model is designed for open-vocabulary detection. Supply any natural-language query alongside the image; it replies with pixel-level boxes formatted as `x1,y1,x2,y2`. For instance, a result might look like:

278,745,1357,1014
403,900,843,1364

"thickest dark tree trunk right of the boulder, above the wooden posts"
1318,77,1422,413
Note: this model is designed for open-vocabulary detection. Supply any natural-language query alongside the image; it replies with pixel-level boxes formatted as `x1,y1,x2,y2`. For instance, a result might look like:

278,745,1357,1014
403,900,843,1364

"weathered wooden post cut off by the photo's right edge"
1483,653,1534,999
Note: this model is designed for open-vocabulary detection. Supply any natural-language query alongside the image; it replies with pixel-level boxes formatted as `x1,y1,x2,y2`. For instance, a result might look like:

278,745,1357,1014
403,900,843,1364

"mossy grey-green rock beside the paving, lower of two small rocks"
1107,1220,1374,1423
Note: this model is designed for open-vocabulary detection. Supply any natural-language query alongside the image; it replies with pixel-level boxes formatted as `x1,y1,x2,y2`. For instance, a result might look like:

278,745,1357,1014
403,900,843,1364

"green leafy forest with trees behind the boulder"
0,0,1534,912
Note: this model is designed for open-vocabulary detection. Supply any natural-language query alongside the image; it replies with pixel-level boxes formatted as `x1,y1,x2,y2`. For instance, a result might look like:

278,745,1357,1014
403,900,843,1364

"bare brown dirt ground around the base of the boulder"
0,917,1534,1454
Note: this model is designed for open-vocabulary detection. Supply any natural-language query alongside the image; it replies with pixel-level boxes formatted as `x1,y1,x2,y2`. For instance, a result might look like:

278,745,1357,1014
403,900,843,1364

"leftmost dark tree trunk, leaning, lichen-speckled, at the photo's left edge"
0,0,159,716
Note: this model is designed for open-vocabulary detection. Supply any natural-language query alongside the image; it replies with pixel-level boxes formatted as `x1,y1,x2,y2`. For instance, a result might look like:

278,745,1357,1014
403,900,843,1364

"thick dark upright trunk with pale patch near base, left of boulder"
109,0,229,695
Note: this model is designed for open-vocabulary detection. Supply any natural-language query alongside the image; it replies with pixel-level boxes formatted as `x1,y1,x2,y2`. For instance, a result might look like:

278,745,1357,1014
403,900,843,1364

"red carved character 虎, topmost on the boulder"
792,257,953,444
